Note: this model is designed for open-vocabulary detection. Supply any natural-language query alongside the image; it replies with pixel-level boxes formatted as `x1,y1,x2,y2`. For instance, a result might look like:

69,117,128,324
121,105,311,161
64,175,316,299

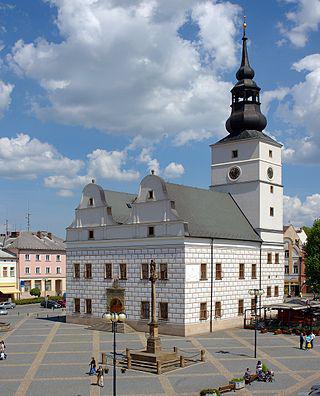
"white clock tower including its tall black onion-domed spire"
211,23,283,245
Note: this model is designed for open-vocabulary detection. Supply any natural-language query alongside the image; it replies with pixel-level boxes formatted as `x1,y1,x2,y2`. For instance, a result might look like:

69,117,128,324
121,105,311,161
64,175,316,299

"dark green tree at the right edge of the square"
304,219,320,298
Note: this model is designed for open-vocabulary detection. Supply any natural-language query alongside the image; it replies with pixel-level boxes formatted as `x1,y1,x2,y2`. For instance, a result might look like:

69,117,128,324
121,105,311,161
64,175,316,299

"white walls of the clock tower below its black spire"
211,139,283,246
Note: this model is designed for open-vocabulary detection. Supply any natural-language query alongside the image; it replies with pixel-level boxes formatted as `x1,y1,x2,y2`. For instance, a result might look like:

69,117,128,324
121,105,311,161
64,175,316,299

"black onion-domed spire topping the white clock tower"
226,24,267,135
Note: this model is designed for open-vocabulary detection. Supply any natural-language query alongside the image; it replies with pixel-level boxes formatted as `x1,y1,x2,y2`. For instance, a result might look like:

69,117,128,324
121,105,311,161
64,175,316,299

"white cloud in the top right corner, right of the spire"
279,0,320,47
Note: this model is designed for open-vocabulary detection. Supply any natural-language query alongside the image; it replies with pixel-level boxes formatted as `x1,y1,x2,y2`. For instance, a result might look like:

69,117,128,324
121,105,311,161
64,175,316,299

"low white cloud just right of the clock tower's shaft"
283,194,320,226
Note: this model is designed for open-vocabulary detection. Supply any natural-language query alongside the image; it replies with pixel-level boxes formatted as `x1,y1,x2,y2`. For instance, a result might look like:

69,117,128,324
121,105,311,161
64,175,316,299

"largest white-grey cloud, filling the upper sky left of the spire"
8,0,240,142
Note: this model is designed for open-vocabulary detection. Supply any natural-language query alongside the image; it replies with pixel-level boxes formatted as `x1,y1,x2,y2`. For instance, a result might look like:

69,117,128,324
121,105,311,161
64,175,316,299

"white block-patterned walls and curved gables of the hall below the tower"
66,175,283,335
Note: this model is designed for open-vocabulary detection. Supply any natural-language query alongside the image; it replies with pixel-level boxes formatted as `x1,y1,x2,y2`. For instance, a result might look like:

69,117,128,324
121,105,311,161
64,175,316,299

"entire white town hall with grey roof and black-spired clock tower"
66,25,284,335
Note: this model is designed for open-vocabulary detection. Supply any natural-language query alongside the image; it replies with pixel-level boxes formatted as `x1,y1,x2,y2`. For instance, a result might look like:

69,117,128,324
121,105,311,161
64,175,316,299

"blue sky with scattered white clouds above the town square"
0,0,320,236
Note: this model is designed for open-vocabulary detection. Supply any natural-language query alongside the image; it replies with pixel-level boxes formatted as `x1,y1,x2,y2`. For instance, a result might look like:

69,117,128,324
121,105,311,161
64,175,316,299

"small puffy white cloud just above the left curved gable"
87,149,140,181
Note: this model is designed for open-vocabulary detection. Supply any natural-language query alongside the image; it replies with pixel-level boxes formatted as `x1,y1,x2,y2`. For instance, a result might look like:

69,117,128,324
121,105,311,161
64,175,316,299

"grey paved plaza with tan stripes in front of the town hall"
0,306,320,396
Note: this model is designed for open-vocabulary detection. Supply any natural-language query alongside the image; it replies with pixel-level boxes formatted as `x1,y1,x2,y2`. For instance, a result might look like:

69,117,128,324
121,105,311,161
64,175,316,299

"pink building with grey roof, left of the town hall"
4,231,66,298
